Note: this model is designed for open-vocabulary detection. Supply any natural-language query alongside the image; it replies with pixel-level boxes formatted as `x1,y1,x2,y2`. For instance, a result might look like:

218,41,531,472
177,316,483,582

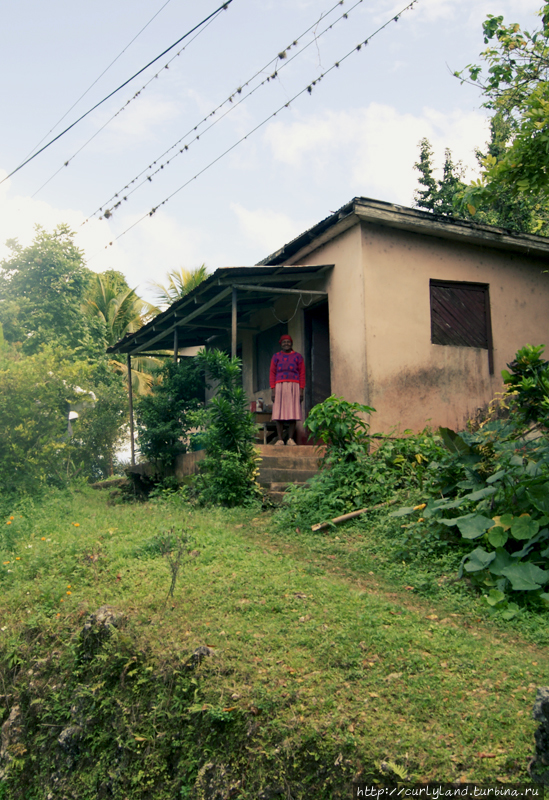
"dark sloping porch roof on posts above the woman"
107,264,333,355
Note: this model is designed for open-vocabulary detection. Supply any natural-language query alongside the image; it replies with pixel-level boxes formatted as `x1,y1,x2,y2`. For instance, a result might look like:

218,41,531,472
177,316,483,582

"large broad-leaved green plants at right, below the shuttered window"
394,345,549,619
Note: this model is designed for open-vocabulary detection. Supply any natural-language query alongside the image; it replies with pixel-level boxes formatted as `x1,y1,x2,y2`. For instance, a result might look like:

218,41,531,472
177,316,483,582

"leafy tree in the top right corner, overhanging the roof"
456,3,549,225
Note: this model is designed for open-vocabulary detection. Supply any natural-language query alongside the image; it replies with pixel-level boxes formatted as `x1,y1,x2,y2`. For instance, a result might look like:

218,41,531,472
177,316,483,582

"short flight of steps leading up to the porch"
256,444,323,503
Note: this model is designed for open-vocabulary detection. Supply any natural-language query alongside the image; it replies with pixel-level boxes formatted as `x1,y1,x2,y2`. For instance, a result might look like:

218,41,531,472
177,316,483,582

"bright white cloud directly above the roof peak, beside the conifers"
265,103,487,205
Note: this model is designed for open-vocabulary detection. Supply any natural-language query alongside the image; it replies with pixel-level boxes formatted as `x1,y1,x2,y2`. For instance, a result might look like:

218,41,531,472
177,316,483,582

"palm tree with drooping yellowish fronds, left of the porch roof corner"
82,271,160,394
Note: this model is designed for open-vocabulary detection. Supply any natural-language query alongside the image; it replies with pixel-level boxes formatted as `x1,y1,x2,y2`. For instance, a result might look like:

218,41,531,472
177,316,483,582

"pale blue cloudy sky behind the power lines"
0,0,541,300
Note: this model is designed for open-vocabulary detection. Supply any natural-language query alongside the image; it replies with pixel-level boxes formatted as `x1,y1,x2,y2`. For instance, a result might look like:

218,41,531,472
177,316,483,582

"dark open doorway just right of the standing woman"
304,302,332,415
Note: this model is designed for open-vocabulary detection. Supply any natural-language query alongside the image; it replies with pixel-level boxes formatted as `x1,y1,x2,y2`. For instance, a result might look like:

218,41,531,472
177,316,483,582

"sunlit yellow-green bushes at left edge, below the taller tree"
0,347,126,494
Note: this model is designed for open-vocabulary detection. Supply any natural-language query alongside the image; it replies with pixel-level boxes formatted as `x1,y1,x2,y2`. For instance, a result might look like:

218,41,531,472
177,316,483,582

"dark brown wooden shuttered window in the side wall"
429,280,494,375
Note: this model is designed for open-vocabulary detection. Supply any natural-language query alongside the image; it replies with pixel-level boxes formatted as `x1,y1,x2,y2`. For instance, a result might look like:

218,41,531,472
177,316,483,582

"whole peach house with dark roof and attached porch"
107,197,549,440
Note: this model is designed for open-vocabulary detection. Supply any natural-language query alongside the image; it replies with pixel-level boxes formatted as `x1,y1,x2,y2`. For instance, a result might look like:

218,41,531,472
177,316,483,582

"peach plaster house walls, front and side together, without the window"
250,203,549,431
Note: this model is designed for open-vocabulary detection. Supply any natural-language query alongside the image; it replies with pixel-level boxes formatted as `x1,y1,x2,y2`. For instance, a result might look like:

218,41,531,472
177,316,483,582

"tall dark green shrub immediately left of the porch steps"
195,350,260,506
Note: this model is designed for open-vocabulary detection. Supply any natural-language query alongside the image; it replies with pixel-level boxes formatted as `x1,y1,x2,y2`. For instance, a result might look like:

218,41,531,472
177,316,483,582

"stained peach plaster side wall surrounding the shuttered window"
362,223,549,431
